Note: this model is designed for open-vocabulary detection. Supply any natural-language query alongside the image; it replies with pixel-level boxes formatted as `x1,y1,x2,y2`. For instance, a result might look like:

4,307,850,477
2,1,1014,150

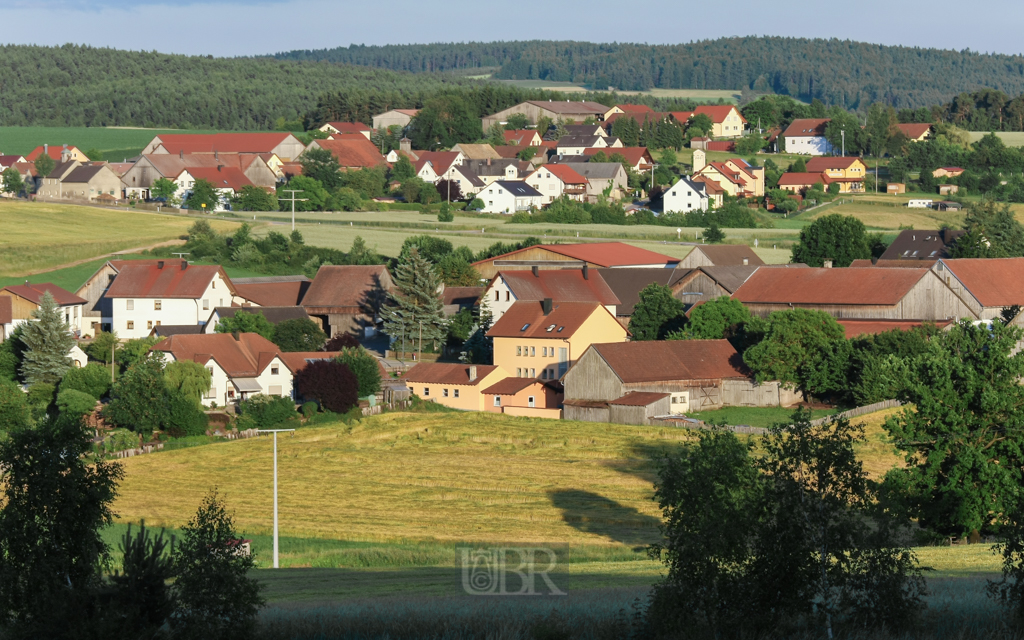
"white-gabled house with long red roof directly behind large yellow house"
480,265,618,322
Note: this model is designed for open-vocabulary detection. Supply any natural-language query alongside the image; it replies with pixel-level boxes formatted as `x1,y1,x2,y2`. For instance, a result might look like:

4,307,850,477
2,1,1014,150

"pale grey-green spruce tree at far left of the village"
22,291,75,385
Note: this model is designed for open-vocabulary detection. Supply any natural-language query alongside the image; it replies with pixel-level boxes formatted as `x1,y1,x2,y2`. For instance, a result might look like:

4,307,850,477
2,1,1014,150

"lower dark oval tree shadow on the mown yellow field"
549,489,662,546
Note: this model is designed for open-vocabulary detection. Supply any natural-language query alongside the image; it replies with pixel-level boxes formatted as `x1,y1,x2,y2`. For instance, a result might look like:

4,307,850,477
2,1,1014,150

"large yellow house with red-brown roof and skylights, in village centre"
487,298,630,380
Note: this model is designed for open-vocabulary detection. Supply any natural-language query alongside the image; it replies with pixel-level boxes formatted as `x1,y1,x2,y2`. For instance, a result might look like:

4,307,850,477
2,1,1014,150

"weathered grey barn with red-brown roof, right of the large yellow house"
562,340,799,424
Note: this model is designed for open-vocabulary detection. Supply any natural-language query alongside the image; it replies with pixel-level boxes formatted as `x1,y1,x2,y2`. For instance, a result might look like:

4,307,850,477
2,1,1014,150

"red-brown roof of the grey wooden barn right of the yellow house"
591,340,750,384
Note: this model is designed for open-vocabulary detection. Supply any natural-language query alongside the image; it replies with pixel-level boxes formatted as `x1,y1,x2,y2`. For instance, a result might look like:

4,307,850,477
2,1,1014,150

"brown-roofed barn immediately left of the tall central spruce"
302,264,394,338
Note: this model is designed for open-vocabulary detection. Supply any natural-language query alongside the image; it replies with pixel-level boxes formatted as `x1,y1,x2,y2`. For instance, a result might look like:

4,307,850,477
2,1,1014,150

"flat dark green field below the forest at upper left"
0,127,235,162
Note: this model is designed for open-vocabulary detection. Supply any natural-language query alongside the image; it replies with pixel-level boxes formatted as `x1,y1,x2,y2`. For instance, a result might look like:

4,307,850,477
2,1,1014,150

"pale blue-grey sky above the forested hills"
6,0,1024,58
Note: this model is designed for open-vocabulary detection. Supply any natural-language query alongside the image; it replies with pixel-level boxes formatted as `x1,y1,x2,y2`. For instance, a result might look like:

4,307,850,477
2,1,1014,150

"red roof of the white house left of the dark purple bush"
150,334,284,378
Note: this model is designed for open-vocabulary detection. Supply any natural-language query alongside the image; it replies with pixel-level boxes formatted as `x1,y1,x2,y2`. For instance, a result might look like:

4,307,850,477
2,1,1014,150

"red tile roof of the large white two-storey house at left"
104,260,233,299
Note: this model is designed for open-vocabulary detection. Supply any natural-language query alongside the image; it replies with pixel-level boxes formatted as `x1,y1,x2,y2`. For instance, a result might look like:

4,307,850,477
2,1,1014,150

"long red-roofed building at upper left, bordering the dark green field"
142,132,306,162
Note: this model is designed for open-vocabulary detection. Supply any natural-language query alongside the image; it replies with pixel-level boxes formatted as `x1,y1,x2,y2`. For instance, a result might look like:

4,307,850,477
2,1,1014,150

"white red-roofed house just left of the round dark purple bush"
150,333,294,407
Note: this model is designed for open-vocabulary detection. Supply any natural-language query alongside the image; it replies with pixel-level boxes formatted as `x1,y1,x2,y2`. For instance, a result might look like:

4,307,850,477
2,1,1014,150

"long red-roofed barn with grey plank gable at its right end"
732,259,974,321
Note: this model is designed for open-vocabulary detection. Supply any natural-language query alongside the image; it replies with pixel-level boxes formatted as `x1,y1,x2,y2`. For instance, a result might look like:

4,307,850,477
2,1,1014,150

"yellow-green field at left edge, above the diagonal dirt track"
0,199,237,278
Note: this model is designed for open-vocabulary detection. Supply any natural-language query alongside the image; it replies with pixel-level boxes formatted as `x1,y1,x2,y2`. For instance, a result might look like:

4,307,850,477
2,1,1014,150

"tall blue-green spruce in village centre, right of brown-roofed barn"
381,247,445,351
